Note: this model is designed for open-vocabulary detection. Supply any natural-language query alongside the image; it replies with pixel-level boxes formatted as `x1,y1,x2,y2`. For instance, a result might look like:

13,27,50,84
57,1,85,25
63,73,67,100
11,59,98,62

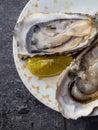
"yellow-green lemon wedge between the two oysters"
28,56,73,77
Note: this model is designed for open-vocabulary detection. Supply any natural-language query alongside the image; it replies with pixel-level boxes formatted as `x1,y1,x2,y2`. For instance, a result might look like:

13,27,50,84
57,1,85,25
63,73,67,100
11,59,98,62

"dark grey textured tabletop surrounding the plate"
0,0,98,130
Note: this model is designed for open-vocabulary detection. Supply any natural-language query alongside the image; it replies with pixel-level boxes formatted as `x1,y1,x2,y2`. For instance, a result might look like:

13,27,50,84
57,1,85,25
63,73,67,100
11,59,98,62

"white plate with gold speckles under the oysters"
13,0,98,111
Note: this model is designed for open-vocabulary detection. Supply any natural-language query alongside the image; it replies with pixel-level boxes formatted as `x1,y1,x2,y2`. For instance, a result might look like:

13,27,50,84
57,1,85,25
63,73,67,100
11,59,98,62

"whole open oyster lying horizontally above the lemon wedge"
15,13,97,57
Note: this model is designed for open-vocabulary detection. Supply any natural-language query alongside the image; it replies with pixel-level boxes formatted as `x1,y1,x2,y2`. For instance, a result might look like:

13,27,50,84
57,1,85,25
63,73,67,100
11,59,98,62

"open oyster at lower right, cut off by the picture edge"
56,39,98,119
